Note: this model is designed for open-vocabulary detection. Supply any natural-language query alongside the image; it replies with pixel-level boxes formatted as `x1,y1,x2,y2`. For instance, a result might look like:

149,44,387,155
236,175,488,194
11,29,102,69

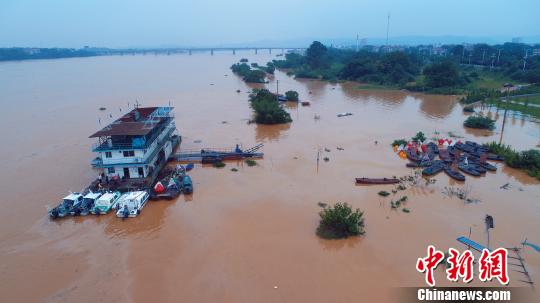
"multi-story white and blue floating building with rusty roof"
90,107,180,183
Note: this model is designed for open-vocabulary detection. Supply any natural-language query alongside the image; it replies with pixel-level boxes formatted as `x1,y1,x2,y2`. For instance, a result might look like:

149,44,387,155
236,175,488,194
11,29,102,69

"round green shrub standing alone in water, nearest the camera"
317,202,365,239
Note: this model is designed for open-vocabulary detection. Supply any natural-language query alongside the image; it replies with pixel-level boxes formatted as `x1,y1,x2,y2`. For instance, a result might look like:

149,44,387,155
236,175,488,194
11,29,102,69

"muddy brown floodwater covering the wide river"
0,52,540,302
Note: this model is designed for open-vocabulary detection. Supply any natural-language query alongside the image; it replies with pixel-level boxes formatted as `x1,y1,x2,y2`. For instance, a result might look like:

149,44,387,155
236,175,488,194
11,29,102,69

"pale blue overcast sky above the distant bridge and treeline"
0,0,540,47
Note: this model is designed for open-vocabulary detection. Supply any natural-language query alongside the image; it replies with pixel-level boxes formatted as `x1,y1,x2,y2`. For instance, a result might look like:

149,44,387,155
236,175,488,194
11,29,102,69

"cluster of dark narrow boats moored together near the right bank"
406,141,504,181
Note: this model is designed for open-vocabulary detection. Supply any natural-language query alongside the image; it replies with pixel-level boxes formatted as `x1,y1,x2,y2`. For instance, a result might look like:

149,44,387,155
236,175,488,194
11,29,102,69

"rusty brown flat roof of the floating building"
90,107,173,138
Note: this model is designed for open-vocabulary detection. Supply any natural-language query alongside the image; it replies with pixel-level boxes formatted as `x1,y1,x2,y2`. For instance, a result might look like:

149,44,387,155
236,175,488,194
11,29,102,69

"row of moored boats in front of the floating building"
48,166,193,219
